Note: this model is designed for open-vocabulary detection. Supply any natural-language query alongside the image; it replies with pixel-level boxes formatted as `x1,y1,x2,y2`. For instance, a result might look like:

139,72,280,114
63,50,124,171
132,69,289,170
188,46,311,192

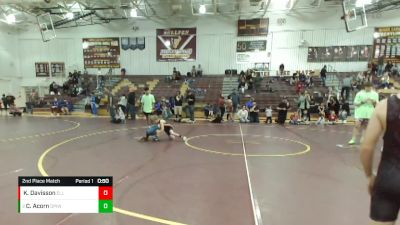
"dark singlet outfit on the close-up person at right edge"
370,95,400,222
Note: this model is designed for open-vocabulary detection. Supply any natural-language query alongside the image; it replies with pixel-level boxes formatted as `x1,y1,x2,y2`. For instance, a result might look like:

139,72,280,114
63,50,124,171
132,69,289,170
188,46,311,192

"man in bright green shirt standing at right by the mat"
348,83,379,145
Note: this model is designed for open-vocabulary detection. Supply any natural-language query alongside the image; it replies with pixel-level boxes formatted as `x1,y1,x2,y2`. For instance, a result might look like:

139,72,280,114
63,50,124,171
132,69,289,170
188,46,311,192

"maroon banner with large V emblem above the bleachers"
157,28,196,62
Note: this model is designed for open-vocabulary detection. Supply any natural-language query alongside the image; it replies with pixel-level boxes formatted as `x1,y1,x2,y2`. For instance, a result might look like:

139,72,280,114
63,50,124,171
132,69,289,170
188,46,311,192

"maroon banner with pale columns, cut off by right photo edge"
373,27,400,63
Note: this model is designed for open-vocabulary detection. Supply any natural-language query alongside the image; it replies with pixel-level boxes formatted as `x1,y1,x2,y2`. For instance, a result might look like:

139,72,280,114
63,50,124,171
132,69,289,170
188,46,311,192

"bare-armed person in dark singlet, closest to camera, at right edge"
360,94,400,225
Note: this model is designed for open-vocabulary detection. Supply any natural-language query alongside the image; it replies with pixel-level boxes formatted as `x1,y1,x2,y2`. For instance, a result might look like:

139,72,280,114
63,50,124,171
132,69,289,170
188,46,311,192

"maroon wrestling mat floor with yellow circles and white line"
0,116,380,225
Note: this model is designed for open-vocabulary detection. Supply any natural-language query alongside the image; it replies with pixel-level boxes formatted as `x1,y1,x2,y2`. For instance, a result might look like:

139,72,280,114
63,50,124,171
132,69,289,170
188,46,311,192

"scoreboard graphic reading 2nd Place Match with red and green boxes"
18,177,113,213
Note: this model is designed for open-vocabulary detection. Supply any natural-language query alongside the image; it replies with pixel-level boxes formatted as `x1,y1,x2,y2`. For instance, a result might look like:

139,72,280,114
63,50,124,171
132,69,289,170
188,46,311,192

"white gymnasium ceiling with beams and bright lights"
0,0,400,29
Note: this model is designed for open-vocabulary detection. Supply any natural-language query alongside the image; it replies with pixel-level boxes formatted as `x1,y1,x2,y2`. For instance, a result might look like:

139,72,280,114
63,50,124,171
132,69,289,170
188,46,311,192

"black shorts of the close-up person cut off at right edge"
370,163,400,222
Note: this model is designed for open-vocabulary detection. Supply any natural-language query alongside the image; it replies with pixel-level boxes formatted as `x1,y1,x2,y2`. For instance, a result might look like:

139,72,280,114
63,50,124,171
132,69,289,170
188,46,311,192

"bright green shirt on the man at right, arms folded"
354,90,379,119
